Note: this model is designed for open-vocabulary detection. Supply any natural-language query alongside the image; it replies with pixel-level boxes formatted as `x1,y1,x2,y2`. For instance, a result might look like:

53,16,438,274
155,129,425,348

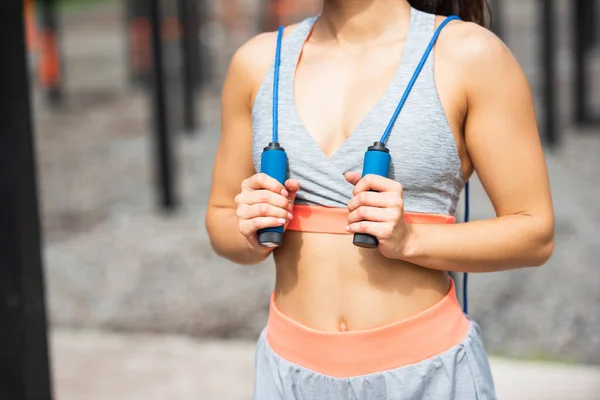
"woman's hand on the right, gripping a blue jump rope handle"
345,172,411,258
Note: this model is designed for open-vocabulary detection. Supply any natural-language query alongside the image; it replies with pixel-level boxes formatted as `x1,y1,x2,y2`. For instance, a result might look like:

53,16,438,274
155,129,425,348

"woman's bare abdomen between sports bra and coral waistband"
275,231,450,331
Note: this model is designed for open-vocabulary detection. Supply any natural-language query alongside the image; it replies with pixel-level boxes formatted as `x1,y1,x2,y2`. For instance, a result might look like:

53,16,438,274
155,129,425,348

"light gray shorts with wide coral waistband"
254,287,496,400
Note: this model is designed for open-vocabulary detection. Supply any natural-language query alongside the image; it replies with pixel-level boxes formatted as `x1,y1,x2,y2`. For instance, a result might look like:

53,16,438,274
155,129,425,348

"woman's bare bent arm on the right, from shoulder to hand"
349,24,554,272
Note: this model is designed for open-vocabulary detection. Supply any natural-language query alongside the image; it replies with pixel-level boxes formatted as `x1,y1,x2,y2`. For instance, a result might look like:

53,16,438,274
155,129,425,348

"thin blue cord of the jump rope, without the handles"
273,15,469,314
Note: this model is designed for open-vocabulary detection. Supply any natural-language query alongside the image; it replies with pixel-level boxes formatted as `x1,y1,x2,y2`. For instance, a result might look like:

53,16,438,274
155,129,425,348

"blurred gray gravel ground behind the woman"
34,1,600,364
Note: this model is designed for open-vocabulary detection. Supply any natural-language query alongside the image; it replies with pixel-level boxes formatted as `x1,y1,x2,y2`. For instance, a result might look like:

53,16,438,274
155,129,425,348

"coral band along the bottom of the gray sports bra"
287,204,456,234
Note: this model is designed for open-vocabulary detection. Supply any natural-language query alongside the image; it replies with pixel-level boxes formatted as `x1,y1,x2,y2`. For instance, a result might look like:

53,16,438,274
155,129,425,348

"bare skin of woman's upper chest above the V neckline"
293,46,401,157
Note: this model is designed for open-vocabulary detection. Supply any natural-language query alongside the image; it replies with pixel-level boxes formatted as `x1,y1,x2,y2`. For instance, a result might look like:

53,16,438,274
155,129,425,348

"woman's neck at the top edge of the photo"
313,0,410,44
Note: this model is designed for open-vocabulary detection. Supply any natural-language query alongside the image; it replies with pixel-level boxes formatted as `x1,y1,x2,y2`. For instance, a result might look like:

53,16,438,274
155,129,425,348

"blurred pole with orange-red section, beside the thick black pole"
37,0,63,105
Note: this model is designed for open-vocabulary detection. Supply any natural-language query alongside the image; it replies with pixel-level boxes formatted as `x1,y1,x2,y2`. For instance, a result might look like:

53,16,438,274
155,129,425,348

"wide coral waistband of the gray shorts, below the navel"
266,282,471,378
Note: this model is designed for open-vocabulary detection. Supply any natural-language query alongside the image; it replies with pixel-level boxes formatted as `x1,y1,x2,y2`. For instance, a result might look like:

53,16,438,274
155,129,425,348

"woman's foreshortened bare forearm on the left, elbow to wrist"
206,207,271,265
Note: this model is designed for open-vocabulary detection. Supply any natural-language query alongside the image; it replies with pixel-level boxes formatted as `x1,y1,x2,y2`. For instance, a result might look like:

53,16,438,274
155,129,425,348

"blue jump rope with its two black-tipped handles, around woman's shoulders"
258,15,469,313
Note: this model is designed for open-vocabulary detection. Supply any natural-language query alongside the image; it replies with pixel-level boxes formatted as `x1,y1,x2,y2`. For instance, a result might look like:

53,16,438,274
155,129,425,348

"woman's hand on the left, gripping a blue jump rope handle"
235,173,300,252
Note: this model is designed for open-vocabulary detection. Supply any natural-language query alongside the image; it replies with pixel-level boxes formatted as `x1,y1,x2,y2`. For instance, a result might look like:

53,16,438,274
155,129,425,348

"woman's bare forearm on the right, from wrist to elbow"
396,215,554,272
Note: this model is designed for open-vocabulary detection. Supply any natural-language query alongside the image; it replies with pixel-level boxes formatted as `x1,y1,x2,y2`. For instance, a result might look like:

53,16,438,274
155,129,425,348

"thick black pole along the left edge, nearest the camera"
0,0,52,400
